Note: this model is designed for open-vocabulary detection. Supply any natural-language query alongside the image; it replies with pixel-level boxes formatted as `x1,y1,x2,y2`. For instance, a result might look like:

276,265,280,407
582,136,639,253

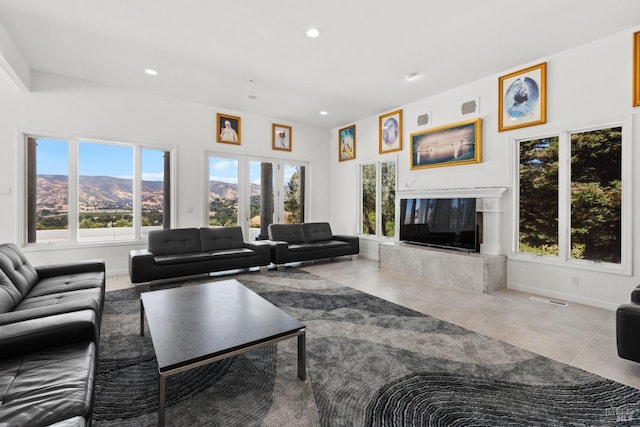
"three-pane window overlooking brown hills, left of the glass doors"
25,136,171,244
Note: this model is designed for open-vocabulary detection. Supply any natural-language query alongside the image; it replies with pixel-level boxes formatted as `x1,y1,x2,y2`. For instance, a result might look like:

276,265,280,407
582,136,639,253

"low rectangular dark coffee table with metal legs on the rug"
140,280,307,426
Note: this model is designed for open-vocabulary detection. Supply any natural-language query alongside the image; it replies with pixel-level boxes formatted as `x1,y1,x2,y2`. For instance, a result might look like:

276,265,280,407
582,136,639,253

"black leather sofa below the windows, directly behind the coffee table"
129,227,271,283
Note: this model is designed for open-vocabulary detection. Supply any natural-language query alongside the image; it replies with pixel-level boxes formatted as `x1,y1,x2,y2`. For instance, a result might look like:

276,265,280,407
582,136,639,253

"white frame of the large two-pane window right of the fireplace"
509,118,633,276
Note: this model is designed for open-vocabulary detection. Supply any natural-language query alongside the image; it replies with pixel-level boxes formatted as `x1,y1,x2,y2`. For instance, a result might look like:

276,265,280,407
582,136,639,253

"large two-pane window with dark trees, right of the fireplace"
517,125,631,266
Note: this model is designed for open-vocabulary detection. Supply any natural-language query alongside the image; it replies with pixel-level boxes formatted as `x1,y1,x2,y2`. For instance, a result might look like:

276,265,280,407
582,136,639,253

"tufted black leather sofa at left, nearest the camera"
0,243,105,427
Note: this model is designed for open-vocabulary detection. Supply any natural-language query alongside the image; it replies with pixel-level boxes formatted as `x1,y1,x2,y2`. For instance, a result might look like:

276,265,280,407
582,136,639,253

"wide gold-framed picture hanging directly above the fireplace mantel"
410,119,482,169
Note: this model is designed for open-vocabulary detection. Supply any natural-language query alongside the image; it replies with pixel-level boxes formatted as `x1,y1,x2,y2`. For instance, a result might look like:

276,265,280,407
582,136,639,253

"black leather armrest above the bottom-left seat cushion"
0,310,100,357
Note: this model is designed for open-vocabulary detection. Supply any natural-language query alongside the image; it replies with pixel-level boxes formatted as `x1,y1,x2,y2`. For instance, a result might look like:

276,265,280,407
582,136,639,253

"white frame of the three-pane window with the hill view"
17,131,177,250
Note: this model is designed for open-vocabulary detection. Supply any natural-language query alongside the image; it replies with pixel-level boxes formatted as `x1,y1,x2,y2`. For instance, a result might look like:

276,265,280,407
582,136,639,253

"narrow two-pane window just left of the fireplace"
360,161,396,237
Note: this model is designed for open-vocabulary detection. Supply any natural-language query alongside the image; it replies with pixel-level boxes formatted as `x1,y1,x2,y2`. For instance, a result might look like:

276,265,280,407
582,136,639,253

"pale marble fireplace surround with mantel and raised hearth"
378,187,507,294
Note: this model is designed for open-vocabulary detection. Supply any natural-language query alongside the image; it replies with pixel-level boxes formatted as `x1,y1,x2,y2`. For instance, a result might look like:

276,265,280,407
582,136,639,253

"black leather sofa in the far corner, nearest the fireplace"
268,222,360,268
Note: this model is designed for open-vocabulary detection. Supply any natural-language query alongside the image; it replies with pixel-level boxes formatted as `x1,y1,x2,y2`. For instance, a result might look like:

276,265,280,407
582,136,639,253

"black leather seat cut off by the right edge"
616,285,640,362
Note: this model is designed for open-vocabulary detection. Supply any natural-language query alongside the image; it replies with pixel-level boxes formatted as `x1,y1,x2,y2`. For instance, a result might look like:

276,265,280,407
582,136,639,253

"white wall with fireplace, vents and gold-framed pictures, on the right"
330,29,640,308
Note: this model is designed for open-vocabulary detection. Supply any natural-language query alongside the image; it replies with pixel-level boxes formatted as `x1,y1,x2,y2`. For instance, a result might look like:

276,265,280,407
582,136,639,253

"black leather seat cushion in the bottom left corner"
0,341,98,426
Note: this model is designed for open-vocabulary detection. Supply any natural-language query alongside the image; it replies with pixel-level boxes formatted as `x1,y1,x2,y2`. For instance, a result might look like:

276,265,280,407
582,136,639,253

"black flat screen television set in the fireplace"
400,197,478,252
